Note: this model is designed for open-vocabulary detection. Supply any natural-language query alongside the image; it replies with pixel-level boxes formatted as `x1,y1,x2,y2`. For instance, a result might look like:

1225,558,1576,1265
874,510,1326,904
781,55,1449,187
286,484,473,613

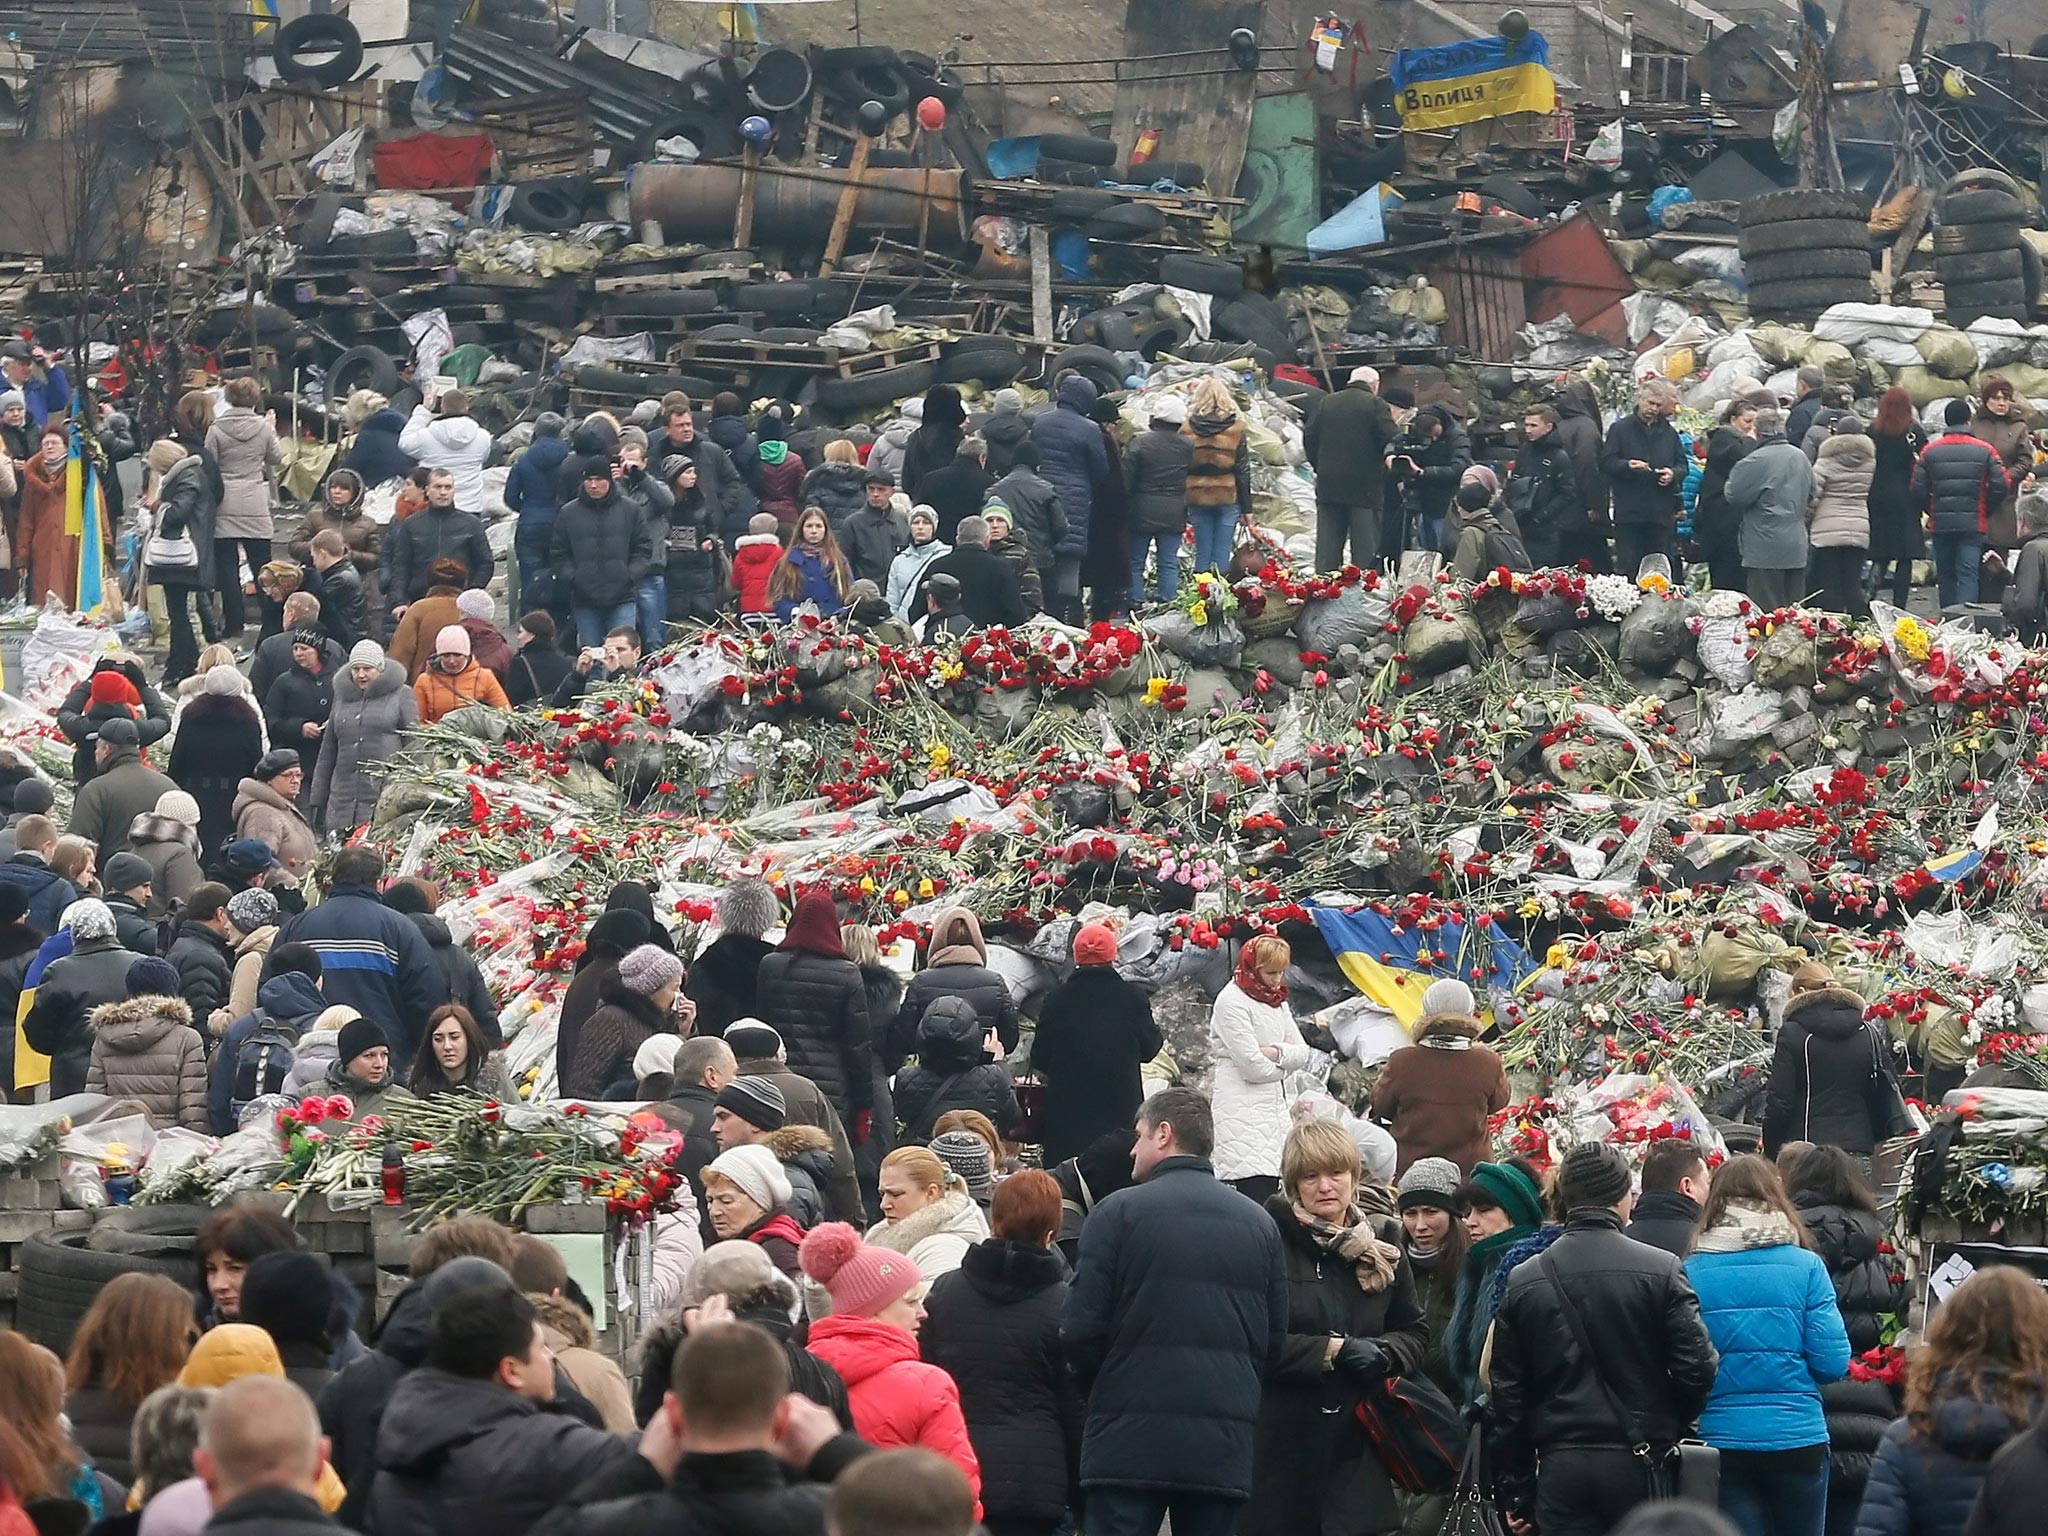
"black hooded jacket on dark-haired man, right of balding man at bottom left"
369,1366,639,1536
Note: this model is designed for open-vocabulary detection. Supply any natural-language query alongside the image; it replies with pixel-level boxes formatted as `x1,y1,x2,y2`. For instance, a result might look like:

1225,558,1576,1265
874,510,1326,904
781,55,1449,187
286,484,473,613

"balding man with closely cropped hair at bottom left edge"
193,1376,342,1536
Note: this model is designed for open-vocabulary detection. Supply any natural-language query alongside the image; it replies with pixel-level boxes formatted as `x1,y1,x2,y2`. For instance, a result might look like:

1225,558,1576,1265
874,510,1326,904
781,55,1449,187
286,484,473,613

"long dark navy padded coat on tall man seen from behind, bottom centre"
1059,1157,1286,1499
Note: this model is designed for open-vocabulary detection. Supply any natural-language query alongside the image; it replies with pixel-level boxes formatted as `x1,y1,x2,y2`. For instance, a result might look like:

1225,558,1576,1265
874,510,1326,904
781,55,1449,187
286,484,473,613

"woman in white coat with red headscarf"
1208,934,1315,1204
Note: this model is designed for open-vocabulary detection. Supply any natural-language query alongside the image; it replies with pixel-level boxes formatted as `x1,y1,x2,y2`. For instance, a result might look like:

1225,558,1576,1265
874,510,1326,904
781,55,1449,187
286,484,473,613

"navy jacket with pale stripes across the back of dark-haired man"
274,885,449,1077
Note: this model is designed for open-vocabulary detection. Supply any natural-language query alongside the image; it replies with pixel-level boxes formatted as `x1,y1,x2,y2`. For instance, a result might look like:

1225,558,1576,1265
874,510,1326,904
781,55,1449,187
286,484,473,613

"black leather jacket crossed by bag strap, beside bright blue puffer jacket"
1491,1208,1720,1513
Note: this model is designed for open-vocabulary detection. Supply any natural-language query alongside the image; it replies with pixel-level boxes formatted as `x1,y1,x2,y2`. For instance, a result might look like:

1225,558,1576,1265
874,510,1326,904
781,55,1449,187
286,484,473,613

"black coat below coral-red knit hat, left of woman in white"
1030,965,1165,1165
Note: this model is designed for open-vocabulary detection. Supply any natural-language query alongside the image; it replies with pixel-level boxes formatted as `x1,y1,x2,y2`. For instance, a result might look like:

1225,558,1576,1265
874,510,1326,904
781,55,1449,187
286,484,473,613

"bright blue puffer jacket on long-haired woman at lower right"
1686,1243,1849,1450
